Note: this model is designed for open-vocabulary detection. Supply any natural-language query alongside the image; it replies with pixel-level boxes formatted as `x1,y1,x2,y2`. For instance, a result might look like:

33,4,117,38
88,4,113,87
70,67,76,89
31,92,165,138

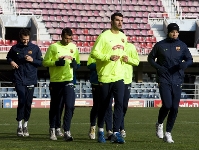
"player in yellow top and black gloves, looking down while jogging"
43,28,77,141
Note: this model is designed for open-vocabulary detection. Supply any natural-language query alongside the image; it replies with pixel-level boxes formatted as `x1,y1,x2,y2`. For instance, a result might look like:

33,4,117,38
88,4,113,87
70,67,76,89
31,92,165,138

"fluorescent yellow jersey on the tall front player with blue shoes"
90,30,127,83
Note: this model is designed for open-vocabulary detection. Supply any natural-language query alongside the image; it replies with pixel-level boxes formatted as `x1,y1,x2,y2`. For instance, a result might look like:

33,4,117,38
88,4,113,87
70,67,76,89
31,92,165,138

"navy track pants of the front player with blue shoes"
97,80,124,132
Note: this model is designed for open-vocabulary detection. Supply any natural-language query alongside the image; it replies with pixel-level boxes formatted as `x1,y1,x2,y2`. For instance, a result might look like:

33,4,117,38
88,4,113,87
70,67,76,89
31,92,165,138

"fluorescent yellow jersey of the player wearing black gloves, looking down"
43,41,77,82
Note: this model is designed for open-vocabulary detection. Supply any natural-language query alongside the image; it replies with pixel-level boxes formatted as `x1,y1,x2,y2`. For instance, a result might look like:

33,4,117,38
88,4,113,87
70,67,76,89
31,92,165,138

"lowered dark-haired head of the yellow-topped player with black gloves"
61,28,73,45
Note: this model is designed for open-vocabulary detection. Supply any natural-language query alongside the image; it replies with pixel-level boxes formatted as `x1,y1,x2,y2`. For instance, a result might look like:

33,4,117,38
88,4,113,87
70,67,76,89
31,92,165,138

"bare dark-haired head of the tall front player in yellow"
111,12,123,30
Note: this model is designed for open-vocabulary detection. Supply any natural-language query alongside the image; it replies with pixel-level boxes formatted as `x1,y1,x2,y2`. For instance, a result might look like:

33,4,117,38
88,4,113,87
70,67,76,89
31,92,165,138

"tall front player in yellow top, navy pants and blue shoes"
90,13,127,143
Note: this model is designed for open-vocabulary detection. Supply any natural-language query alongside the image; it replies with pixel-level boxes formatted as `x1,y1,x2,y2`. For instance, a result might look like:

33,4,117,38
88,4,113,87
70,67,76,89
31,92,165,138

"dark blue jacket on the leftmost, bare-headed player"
7,42,43,85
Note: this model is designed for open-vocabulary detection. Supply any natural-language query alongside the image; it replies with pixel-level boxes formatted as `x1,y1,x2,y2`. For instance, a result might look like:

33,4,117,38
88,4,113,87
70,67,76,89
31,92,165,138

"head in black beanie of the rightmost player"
167,23,179,39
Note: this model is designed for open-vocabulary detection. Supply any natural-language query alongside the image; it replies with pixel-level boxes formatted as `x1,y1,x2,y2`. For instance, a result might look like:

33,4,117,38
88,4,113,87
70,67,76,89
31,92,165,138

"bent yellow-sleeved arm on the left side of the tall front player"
90,34,111,61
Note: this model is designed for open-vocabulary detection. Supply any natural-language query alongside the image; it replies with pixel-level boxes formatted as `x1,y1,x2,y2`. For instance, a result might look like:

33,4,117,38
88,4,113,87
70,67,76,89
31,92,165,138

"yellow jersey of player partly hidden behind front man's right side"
124,43,140,84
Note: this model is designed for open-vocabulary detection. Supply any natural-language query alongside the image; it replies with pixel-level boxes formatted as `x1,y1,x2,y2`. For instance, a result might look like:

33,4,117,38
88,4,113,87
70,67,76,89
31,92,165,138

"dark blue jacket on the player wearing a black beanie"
148,38,193,84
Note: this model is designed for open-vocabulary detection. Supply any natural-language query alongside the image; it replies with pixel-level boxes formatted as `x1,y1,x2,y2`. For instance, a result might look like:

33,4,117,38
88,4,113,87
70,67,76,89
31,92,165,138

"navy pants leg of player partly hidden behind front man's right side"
120,84,131,131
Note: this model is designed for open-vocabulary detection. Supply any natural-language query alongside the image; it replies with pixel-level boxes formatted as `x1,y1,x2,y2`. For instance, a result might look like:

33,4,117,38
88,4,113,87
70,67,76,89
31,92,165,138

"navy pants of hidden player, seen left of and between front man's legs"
90,84,113,131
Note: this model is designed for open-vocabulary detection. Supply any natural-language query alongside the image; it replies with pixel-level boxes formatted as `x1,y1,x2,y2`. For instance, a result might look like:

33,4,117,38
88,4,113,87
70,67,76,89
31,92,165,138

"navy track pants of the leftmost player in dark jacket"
15,84,34,121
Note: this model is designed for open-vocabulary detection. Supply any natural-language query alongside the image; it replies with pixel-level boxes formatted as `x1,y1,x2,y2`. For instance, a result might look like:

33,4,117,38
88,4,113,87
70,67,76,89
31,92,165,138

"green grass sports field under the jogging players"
0,107,199,150
